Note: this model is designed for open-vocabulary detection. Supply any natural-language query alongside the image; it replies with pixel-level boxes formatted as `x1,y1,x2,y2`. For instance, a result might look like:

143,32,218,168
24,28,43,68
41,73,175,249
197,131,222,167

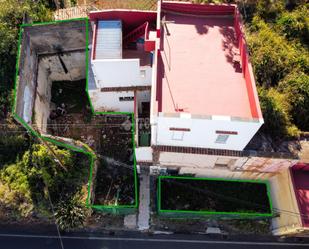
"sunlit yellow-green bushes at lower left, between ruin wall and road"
0,140,89,229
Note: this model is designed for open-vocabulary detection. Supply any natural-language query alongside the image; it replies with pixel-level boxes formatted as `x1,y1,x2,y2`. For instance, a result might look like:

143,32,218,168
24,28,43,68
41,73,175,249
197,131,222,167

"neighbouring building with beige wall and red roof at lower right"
271,163,309,236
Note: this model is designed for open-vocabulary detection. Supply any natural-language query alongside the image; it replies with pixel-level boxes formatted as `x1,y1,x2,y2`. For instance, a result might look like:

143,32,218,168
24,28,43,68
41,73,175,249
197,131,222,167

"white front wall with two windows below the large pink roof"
153,114,262,150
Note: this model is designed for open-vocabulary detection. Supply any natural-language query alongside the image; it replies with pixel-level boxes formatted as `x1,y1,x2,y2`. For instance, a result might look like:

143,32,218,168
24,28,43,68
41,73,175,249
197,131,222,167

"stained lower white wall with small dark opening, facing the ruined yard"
89,90,134,112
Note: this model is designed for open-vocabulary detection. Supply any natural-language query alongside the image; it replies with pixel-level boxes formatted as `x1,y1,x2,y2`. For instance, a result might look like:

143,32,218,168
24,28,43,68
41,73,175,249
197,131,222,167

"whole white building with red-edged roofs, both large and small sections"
89,3,263,161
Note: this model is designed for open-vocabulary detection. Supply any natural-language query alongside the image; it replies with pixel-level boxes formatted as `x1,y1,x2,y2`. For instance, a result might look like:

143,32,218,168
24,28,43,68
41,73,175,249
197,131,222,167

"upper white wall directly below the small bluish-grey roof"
91,59,151,88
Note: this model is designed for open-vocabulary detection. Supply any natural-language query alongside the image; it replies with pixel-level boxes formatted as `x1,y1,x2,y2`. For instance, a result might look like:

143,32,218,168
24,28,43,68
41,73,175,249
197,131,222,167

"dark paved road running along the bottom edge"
0,234,309,249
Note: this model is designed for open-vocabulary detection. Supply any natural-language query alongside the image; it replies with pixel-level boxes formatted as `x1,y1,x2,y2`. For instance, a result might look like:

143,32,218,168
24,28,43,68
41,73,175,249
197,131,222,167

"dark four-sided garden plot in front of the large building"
158,176,272,216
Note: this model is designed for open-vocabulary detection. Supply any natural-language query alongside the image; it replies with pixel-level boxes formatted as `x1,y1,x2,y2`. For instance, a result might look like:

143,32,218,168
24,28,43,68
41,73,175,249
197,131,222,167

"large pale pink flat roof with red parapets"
157,13,252,118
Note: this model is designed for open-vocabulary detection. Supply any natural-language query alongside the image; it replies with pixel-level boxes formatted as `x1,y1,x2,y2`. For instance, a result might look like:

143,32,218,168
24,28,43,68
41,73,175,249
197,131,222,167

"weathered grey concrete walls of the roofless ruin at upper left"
15,21,86,129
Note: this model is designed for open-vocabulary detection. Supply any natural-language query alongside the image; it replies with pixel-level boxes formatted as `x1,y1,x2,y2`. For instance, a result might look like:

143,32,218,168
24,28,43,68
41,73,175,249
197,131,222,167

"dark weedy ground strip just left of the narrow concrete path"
92,115,137,209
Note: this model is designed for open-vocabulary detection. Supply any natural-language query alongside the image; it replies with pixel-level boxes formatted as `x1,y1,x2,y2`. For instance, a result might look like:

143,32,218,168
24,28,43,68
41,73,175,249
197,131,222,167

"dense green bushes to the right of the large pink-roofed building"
242,0,309,138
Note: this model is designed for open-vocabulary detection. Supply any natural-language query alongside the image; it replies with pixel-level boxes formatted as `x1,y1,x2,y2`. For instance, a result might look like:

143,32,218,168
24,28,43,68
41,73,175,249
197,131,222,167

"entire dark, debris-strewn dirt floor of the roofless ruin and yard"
48,81,135,208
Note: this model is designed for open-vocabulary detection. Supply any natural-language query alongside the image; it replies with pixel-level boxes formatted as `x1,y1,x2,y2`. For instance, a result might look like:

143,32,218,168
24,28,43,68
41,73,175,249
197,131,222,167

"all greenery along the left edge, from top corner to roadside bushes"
0,0,89,229
